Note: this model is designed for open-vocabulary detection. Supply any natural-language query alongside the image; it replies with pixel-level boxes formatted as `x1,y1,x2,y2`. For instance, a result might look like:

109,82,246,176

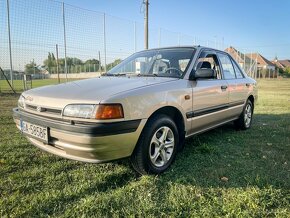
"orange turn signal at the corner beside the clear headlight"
96,104,124,120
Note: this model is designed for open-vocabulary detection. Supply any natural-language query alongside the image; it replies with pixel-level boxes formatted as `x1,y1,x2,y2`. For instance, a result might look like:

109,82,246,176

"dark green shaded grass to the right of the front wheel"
159,114,290,189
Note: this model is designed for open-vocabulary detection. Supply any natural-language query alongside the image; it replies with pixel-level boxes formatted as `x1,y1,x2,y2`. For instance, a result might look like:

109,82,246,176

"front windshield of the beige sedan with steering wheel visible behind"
106,48,195,78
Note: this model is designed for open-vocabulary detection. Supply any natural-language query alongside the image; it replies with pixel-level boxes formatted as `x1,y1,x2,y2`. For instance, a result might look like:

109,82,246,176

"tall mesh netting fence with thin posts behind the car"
0,0,276,91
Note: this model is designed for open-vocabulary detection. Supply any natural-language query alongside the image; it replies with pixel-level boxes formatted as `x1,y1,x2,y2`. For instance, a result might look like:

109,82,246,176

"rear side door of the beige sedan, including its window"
217,52,245,117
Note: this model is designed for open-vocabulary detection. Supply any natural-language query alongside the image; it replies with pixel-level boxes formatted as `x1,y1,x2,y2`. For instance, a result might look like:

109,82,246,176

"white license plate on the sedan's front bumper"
20,120,48,142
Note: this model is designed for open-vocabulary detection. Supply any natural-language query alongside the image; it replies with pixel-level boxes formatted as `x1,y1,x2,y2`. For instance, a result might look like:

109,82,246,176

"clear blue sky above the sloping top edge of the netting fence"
64,0,290,59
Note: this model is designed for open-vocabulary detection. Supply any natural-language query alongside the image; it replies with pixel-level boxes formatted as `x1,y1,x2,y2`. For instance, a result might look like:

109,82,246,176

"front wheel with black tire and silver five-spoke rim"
131,114,179,175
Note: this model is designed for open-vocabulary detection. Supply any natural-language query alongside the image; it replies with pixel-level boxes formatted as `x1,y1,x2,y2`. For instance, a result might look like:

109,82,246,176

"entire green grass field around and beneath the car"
0,79,290,217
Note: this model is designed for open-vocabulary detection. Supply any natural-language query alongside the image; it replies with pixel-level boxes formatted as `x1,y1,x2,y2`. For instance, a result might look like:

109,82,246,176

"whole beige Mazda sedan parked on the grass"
13,46,257,174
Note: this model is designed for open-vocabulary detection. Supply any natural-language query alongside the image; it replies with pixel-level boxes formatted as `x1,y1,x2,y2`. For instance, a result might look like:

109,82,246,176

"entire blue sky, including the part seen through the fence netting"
0,0,290,70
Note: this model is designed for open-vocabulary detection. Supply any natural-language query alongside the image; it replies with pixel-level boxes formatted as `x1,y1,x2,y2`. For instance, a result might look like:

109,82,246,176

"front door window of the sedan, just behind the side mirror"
196,52,222,79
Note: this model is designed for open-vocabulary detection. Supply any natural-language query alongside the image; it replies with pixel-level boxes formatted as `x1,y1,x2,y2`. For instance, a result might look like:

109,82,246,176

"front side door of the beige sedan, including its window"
187,50,229,133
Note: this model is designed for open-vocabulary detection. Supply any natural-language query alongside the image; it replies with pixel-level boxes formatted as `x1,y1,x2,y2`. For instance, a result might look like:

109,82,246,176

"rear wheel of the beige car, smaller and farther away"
234,99,254,130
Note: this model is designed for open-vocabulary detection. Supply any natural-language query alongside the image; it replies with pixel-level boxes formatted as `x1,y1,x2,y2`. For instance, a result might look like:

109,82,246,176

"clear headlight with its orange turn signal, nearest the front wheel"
63,104,124,120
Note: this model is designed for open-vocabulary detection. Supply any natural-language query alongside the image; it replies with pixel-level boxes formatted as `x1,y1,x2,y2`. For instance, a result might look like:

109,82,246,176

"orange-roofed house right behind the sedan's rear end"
225,46,255,73
